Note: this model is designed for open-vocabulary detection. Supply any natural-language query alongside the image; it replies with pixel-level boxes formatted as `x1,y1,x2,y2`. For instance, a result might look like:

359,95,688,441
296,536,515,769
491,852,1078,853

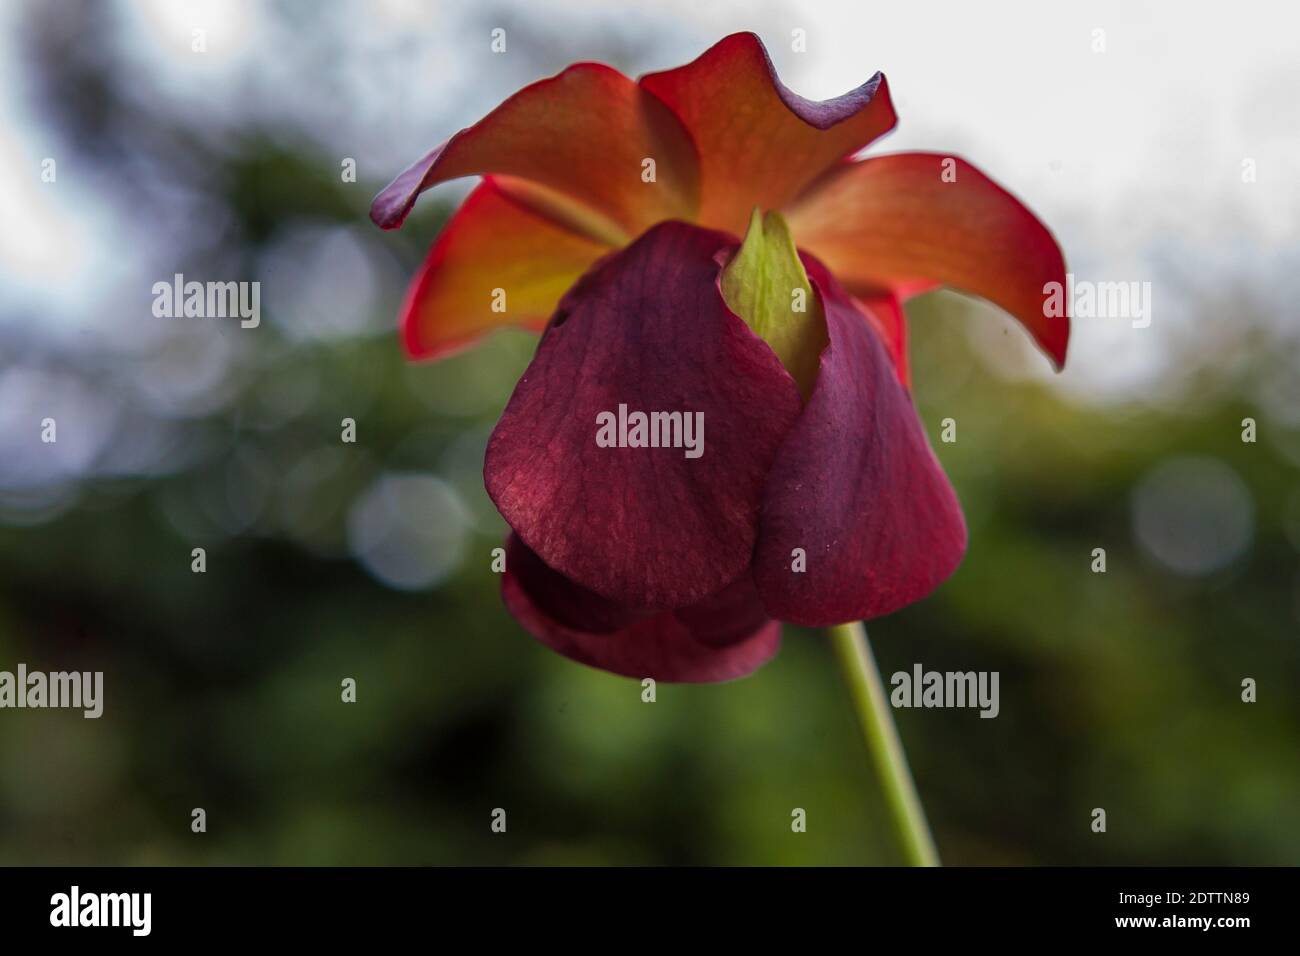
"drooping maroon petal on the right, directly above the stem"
754,258,966,627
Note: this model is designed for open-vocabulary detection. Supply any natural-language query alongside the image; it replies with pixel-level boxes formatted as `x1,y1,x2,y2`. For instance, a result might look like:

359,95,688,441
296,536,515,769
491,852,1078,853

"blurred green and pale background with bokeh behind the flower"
0,0,1300,864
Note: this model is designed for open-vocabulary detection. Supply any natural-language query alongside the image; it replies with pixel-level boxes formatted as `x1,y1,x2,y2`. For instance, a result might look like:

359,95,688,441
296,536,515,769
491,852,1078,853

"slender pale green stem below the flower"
828,620,939,866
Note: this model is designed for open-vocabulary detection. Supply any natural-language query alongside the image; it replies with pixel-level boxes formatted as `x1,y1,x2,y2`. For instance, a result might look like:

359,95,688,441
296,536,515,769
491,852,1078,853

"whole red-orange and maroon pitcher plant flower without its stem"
371,34,1070,680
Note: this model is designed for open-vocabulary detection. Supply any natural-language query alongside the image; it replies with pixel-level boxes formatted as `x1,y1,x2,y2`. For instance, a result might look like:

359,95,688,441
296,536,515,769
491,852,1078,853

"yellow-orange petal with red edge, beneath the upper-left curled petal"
402,177,610,359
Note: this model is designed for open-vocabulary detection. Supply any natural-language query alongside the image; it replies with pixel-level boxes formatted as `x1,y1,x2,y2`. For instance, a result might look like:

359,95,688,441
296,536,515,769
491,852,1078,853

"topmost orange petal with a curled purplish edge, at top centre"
640,33,897,235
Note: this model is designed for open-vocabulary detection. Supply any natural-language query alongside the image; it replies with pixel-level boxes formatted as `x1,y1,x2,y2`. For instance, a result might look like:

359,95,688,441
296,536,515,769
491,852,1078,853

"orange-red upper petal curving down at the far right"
787,152,1070,368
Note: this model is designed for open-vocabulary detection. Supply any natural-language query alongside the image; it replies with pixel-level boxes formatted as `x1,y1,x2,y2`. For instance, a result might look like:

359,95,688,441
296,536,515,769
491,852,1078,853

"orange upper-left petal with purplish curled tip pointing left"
371,62,698,241
